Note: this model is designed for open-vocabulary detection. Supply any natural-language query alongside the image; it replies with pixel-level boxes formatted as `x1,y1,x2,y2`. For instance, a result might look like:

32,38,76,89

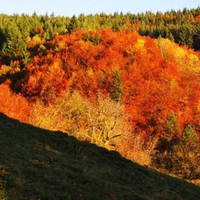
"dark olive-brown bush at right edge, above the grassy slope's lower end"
154,120,200,180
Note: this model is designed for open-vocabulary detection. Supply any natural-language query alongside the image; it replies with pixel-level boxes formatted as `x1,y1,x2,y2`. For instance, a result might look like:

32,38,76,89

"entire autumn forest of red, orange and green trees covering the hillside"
0,7,200,180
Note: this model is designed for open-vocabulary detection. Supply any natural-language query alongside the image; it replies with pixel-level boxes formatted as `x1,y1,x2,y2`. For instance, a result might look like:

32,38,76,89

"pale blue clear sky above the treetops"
0,0,200,17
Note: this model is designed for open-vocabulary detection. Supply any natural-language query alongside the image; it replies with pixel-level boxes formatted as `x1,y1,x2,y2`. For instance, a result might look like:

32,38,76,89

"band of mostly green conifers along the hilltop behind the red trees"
0,8,200,67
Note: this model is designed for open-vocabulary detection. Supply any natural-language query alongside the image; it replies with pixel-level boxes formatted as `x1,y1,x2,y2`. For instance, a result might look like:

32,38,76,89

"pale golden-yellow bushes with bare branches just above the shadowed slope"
30,91,129,149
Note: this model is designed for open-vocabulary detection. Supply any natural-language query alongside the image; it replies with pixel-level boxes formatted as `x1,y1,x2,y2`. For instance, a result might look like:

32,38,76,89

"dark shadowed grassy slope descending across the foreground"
0,114,200,200
